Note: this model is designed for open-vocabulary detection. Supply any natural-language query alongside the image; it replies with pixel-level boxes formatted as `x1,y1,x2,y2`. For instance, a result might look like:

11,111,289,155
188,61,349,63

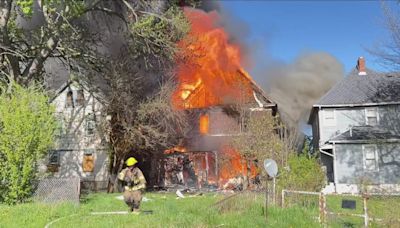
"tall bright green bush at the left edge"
0,84,56,204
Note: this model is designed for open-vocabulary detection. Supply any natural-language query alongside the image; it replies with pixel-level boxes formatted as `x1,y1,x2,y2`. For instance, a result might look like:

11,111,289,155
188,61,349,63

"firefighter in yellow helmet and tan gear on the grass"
118,157,146,214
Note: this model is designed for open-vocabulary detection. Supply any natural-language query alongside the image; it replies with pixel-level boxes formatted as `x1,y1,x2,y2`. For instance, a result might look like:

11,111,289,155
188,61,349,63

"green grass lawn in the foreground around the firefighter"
0,193,320,228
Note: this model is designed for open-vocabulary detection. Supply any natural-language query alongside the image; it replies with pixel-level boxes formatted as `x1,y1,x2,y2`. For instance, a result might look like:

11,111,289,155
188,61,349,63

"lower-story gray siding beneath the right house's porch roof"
334,143,400,184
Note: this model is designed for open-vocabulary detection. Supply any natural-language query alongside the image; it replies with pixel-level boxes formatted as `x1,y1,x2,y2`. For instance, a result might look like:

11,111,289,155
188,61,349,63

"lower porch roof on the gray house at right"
329,126,400,143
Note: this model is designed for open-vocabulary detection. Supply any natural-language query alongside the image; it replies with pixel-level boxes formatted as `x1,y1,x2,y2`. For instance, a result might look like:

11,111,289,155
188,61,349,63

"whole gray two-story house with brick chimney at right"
309,57,400,193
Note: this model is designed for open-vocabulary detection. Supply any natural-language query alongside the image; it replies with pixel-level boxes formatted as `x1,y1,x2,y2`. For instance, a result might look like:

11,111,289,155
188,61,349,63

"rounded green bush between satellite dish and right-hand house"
278,153,325,191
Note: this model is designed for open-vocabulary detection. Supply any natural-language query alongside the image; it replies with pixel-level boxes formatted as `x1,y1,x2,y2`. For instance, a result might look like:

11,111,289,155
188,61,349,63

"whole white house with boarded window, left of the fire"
40,81,109,190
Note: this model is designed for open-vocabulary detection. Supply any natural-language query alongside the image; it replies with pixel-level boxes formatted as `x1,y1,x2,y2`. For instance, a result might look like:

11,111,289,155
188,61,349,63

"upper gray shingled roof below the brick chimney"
314,69,400,107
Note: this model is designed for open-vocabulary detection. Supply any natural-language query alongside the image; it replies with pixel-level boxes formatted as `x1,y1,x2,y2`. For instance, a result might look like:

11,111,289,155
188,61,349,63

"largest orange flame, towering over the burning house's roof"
173,8,252,109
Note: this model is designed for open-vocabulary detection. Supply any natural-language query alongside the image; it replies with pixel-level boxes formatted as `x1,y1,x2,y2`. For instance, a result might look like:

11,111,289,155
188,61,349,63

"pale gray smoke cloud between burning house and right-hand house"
262,52,344,124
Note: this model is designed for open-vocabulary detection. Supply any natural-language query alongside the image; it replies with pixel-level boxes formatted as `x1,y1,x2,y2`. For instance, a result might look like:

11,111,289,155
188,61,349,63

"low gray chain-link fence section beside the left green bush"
33,177,81,204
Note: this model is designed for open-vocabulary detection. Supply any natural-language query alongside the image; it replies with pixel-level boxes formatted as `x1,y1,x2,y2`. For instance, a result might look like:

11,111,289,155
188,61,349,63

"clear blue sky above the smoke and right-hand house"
221,0,388,74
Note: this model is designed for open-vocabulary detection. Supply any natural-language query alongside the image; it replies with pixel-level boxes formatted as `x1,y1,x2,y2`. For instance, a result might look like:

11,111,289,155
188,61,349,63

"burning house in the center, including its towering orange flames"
160,10,277,189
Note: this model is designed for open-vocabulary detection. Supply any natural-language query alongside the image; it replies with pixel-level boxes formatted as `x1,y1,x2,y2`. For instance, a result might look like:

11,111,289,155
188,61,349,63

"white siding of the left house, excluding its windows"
45,84,109,188
